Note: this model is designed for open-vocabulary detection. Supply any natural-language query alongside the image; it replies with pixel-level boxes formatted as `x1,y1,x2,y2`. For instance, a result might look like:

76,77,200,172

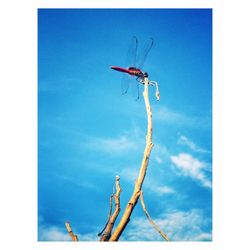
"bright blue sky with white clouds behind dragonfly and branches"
38,9,212,241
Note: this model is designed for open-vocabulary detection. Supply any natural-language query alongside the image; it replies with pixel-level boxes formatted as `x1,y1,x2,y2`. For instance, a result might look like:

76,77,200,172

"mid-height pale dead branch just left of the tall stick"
100,176,122,241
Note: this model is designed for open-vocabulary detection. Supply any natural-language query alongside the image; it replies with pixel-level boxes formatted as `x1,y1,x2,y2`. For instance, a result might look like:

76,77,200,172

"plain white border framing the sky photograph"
0,0,250,250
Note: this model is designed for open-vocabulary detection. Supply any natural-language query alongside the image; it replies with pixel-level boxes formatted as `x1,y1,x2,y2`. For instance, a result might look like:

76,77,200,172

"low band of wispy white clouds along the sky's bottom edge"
38,209,212,241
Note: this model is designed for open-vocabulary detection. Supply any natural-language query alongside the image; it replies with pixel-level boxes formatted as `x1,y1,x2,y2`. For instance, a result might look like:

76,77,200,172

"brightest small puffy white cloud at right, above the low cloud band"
170,153,212,188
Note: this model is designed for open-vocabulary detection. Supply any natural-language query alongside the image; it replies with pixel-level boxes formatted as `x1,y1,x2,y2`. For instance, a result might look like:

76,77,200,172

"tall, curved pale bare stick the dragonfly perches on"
109,77,153,241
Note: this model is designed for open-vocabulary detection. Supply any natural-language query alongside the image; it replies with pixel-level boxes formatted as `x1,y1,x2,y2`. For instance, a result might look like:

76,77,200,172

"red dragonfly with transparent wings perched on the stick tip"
111,36,154,100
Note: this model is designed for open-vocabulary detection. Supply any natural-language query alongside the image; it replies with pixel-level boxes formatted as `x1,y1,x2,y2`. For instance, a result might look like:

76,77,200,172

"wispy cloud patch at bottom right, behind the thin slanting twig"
122,209,212,241
